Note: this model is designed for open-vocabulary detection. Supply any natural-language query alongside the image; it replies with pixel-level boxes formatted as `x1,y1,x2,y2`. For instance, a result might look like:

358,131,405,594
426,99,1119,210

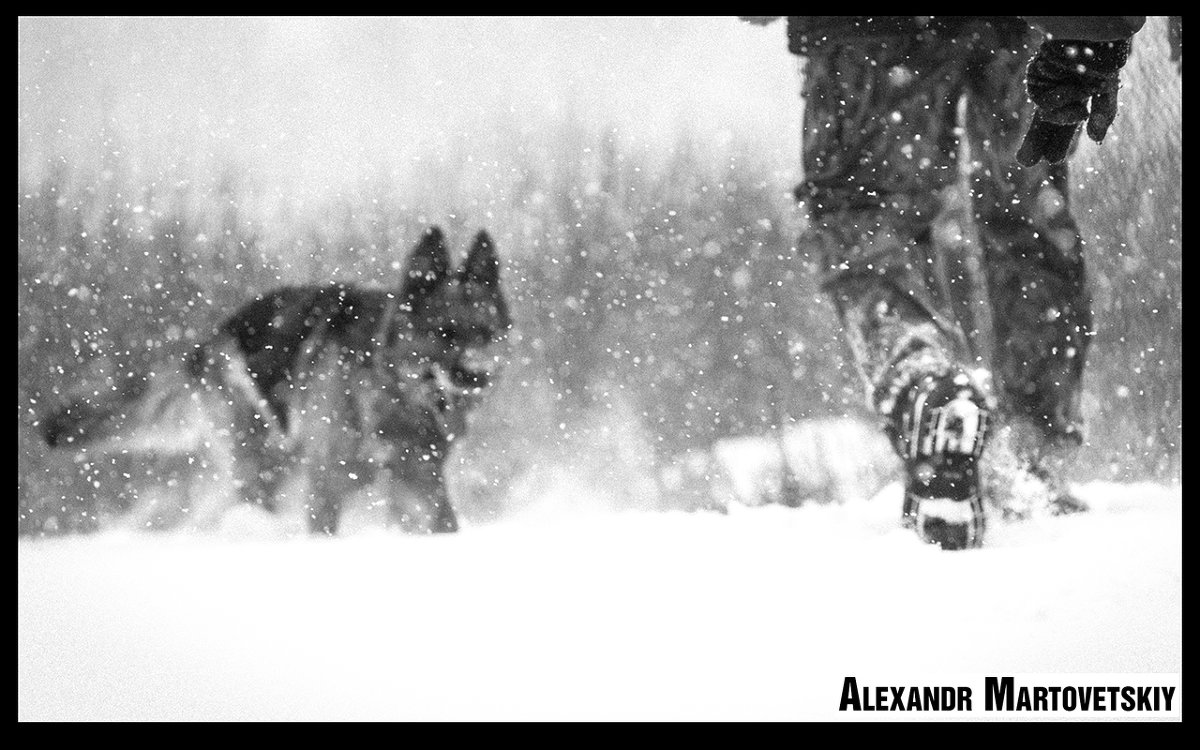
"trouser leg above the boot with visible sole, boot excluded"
797,35,971,436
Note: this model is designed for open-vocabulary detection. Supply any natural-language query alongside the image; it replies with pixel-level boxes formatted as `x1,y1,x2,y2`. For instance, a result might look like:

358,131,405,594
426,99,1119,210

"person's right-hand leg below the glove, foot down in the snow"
966,20,1092,512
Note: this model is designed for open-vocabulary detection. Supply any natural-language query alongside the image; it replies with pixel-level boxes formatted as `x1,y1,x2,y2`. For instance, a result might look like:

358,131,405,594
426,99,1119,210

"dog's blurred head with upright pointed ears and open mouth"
401,227,512,389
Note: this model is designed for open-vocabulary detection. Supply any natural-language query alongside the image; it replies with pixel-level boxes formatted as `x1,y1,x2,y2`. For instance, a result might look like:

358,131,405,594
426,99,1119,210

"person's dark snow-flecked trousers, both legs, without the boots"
797,18,1091,456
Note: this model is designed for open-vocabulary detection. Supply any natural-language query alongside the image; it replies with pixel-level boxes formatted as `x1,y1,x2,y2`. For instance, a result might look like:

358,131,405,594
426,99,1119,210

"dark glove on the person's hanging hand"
1016,40,1129,167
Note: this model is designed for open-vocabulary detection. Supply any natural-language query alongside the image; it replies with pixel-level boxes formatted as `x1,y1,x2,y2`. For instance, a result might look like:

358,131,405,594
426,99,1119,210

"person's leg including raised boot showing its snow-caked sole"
797,34,986,547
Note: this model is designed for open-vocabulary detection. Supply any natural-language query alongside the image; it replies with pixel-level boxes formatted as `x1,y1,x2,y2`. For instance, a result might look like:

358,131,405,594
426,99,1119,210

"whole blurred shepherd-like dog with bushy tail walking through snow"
43,228,511,534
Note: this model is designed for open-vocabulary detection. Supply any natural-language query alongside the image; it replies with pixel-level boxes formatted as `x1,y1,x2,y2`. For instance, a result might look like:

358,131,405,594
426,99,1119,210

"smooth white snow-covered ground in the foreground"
17,485,1182,720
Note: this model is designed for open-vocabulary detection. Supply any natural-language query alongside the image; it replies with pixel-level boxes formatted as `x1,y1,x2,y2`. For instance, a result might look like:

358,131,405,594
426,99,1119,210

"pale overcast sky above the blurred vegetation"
18,17,800,193
